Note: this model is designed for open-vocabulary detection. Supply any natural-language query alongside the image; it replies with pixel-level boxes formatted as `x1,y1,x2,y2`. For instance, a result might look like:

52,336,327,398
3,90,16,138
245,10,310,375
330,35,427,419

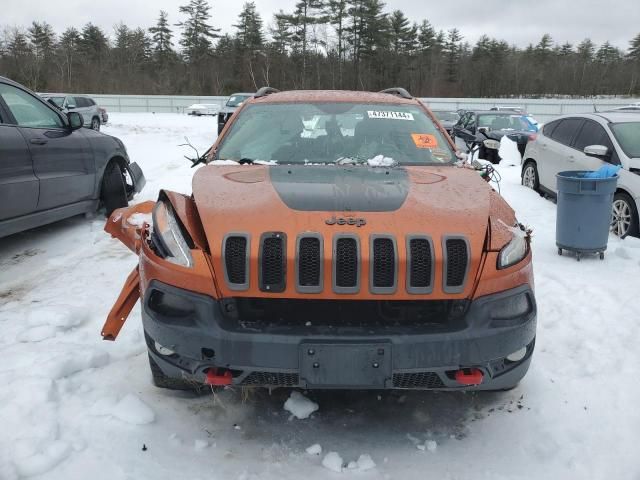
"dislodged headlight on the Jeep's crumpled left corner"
153,201,193,267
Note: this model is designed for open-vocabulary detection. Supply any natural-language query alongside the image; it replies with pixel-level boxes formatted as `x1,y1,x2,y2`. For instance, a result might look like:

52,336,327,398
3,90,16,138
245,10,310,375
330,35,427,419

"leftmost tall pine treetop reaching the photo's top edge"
177,0,220,63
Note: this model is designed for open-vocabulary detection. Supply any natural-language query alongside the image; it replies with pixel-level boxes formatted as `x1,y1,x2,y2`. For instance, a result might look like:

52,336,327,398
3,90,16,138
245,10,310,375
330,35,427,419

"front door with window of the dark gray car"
0,84,96,211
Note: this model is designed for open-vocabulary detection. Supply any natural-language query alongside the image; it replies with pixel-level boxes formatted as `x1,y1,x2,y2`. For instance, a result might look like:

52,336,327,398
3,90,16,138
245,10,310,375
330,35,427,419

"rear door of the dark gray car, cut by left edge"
0,98,39,222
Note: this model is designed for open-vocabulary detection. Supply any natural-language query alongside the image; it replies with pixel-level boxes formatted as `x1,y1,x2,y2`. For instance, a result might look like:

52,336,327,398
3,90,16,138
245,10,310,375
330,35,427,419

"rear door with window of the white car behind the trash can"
538,117,584,192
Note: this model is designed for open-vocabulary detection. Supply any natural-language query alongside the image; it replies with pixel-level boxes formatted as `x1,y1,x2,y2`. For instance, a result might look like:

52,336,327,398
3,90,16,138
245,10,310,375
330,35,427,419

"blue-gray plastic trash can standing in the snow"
556,171,618,261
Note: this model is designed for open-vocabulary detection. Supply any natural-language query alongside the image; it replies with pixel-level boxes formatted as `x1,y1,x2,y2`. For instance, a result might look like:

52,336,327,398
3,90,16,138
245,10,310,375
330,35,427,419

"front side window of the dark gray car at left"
0,84,64,128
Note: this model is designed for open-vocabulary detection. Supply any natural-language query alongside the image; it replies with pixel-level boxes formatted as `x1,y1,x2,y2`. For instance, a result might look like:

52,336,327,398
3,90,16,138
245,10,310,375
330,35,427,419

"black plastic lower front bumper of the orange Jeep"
142,281,536,390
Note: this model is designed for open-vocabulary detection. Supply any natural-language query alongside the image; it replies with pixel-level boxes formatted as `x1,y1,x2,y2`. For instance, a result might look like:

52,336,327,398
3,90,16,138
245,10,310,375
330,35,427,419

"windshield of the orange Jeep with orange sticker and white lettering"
218,103,456,165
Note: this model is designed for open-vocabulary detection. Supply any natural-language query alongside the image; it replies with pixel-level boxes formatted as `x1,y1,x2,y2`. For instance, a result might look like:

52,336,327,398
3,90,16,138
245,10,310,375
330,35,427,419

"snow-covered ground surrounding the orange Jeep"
0,113,640,480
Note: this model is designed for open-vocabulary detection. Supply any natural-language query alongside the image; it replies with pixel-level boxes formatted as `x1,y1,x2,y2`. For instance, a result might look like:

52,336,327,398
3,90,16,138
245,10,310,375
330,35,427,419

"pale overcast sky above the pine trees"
0,0,640,50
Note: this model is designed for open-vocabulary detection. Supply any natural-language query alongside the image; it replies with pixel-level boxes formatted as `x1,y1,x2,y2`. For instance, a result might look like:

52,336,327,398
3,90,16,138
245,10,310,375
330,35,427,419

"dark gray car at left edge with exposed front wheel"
0,77,145,237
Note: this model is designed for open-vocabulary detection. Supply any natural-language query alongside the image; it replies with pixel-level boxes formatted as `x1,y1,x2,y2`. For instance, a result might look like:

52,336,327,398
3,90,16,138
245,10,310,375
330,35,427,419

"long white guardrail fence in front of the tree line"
91,95,638,122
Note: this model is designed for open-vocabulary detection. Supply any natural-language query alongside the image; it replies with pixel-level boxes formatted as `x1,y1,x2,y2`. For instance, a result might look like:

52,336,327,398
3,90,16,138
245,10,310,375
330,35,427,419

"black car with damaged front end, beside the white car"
452,110,538,163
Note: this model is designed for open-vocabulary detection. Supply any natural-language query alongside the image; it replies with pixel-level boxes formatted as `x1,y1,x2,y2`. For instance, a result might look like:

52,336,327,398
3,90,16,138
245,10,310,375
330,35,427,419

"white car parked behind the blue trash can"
522,112,640,237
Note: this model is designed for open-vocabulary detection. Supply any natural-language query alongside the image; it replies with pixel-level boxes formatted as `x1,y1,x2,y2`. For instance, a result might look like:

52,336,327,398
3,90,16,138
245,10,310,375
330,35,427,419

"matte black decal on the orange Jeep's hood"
269,165,409,212
